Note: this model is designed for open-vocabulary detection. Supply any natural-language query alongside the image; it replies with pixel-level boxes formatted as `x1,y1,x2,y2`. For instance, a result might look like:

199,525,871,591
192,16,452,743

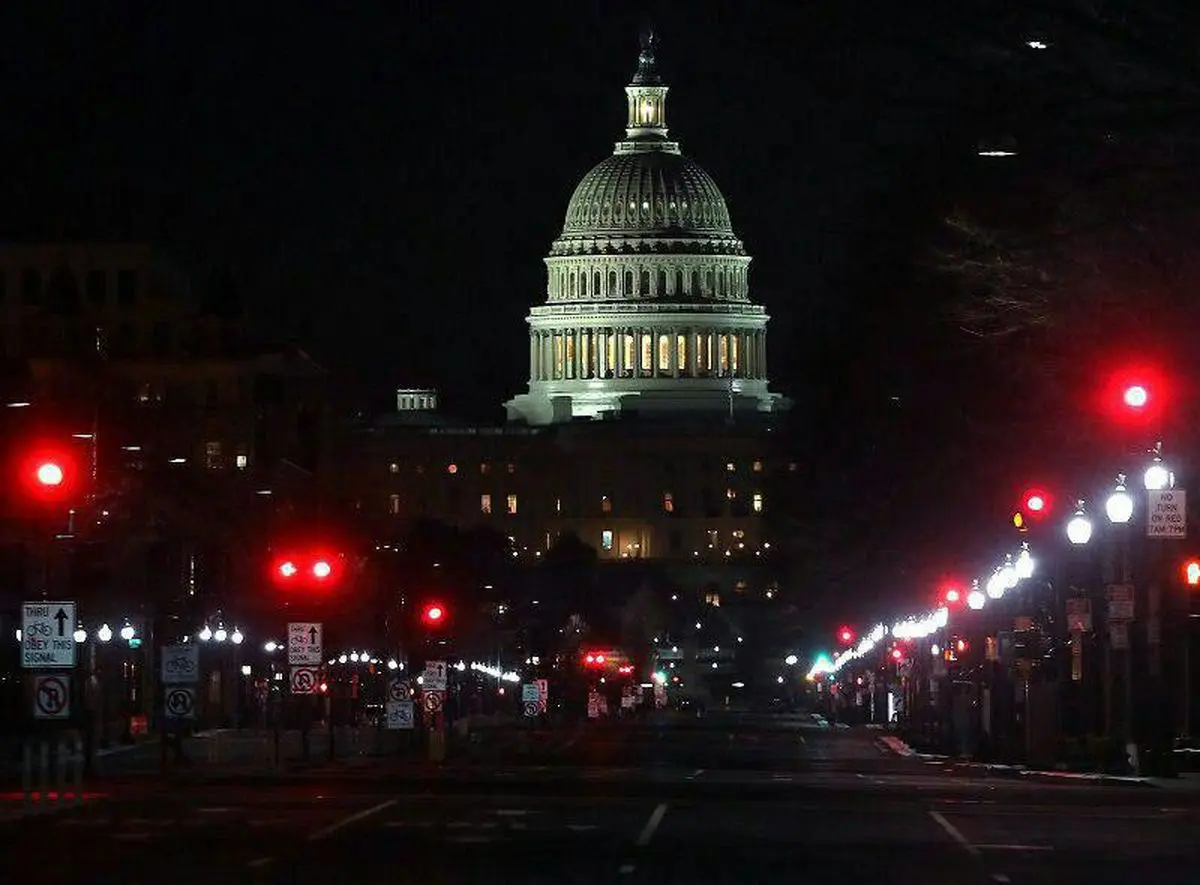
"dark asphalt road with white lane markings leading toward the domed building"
0,717,1200,885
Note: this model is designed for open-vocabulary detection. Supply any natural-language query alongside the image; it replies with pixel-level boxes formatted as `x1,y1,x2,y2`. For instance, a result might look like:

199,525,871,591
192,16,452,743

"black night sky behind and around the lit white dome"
0,0,1147,618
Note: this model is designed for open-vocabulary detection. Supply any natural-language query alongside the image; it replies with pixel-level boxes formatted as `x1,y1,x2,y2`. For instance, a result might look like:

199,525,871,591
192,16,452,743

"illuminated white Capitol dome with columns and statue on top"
505,34,785,425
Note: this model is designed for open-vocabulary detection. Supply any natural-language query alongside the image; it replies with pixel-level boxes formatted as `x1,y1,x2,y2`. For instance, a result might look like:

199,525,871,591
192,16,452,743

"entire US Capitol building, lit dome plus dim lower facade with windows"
341,36,803,565
